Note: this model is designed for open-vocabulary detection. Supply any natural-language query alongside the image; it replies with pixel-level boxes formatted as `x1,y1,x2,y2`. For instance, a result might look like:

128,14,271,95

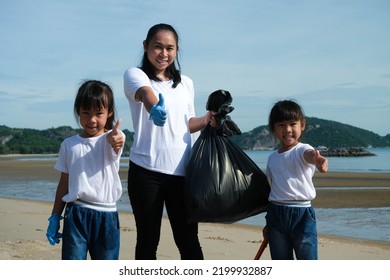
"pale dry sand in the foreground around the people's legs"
0,198,390,260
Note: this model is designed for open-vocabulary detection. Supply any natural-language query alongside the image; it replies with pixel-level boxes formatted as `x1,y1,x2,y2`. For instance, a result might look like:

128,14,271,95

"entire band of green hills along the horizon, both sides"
0,117,390,156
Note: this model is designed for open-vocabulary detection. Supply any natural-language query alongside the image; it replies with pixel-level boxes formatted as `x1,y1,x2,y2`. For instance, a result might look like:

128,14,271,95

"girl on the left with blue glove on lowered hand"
46,80,125,260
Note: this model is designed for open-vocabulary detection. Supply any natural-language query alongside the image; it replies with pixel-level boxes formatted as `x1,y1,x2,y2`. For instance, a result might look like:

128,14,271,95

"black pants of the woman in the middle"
127,162,203,260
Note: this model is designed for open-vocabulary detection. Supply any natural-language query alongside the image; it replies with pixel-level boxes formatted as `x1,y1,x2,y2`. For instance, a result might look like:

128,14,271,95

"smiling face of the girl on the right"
273,120,306,153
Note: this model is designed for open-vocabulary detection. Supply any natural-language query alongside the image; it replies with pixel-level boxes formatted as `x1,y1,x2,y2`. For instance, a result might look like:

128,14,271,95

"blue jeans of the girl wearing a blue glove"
62,203,120,260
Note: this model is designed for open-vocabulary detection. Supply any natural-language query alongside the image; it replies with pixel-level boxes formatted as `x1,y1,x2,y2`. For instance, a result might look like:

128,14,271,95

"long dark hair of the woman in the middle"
140,23,181,88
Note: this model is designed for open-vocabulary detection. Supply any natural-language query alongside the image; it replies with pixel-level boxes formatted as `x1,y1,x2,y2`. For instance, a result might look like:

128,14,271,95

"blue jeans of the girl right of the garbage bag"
265,203,318,260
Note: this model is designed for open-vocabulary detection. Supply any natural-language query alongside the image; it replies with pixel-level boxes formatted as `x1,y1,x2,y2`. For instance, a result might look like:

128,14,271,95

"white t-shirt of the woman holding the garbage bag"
123,68,195,176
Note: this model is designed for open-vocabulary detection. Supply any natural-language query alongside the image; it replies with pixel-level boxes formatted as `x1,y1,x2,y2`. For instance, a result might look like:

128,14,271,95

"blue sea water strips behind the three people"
0,148,390,242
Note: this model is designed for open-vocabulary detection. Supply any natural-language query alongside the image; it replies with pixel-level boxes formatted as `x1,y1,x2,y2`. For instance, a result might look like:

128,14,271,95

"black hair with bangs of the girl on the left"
73,80,115,130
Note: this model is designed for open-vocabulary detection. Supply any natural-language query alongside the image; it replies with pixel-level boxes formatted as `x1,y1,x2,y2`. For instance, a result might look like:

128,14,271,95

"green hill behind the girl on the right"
231,117,390,150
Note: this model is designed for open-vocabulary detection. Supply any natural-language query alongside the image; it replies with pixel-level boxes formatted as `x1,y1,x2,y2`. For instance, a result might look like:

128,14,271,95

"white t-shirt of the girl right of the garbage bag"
266,143,316,204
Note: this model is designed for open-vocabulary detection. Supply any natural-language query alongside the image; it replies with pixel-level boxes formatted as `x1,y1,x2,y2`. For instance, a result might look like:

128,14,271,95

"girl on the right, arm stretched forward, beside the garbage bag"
264,100,328,260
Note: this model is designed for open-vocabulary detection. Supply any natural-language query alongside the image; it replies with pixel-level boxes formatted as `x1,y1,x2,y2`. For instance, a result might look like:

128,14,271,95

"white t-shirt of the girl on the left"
55,132,125,205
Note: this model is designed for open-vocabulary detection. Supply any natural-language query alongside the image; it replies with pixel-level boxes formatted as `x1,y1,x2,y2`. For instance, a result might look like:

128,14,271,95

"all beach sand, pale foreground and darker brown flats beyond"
0,156,390,260
